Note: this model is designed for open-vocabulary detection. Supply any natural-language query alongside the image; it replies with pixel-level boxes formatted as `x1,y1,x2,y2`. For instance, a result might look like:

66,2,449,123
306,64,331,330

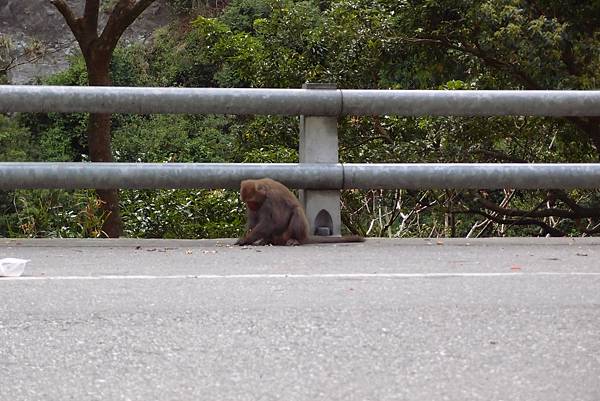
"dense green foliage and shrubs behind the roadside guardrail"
0,0,600,238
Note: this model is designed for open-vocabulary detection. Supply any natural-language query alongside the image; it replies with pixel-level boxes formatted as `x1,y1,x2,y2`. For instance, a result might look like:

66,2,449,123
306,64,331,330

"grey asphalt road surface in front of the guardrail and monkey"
0,239,600,401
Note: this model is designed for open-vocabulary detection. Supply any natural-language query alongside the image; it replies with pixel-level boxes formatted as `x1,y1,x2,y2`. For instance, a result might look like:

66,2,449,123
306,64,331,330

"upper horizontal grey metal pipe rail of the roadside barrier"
0,85,600,116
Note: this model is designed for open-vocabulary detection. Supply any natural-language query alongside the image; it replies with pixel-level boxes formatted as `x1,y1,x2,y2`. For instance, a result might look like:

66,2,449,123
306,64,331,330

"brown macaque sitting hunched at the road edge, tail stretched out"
236,178,364,245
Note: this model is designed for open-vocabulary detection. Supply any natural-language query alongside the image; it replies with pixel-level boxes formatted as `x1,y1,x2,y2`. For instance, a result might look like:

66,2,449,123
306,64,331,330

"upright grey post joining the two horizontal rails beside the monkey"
299,83,342,235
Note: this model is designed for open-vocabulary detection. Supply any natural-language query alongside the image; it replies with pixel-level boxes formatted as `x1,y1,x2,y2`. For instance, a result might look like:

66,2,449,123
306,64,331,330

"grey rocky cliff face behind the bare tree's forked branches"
0,0,171,84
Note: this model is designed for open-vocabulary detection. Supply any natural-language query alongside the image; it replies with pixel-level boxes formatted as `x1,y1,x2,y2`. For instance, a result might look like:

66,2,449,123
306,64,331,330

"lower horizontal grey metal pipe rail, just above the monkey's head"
0,163,600,190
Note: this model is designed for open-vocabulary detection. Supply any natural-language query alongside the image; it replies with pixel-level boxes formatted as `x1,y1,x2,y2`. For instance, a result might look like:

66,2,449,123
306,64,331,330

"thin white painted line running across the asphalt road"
0,272,600,282
